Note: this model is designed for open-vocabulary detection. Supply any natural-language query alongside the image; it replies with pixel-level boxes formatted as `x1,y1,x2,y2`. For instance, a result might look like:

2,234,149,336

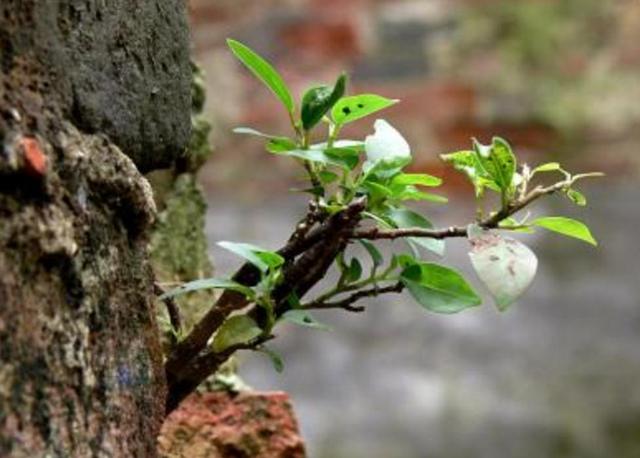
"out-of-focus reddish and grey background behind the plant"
189,0,640,458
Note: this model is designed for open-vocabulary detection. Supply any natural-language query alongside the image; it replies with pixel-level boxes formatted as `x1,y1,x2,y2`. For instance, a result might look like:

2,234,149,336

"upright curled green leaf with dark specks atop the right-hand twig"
473,137,516,194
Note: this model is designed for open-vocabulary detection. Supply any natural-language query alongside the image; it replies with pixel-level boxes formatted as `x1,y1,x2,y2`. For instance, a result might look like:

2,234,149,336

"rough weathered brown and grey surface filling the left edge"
0,0,191,457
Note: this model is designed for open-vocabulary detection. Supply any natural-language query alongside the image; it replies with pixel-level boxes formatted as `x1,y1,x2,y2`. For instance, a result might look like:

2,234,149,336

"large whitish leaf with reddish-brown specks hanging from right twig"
469,233,538,311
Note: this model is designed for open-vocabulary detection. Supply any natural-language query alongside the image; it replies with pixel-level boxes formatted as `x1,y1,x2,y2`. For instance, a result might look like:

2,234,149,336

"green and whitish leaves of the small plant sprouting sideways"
158,40,598,376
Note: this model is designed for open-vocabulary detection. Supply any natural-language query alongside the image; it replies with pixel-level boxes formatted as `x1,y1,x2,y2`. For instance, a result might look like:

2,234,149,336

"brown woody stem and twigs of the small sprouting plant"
165,169,600,412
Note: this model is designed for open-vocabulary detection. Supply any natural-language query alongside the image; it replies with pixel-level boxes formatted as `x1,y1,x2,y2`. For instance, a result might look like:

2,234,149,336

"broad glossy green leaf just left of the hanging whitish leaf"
400,263,482,313
